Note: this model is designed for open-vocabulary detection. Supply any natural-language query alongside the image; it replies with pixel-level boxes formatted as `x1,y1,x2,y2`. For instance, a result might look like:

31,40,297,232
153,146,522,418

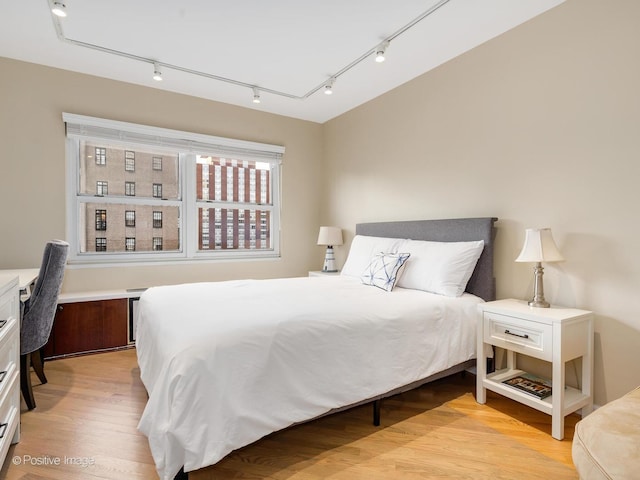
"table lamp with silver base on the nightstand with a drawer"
516,228,564,308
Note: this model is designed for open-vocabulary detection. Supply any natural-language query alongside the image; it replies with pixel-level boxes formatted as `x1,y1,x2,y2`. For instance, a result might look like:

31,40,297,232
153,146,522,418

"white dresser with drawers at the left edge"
0,275,20,462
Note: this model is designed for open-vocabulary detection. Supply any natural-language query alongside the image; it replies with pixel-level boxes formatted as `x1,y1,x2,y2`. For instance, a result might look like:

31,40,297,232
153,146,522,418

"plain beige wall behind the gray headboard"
323,0,640,404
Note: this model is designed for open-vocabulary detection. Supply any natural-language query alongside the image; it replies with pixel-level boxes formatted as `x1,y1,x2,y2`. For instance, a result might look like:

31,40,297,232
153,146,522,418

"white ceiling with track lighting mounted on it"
0,0,564,123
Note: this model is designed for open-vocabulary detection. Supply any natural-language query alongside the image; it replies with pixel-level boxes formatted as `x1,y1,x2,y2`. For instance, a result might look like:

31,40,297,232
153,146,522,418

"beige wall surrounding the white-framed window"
0,58,323,292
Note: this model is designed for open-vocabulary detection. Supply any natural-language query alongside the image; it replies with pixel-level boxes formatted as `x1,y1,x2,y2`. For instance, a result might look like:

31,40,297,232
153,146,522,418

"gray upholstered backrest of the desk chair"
20,240,69,355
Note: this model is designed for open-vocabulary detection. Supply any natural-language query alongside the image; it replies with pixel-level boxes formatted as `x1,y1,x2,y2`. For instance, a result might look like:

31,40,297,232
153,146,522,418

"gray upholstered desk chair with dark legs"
20,240,69,410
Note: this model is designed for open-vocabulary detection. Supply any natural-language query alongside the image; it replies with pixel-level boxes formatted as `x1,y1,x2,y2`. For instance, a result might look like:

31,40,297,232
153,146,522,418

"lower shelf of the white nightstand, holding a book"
482,369,589,416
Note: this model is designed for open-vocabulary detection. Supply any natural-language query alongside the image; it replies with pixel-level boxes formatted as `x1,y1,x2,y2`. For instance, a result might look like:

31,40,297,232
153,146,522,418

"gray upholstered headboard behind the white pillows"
356,217,498,301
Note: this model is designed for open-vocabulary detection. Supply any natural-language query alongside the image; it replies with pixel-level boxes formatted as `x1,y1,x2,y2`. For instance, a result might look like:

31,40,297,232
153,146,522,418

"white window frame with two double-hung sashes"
62,113,285,266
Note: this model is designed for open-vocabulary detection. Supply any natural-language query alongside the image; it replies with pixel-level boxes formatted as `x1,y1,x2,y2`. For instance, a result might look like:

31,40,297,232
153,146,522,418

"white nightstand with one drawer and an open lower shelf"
476,300,593,440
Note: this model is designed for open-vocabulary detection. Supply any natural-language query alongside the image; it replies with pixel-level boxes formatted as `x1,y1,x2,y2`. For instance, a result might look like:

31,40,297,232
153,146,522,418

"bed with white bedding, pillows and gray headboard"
136,218,496,480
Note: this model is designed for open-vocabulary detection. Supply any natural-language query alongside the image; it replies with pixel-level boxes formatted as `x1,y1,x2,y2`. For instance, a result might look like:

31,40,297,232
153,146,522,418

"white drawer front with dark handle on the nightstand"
484,312,553,361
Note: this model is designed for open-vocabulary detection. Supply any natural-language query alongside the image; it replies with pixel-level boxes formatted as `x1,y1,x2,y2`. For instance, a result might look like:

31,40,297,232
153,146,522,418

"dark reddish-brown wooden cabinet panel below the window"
44,298,129,358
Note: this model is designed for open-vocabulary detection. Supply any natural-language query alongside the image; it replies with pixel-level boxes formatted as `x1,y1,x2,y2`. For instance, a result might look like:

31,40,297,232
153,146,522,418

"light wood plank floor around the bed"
0,350,578,480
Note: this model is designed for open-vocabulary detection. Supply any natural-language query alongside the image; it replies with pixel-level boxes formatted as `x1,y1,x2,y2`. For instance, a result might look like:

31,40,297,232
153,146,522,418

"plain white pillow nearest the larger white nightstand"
397,240,484,297
